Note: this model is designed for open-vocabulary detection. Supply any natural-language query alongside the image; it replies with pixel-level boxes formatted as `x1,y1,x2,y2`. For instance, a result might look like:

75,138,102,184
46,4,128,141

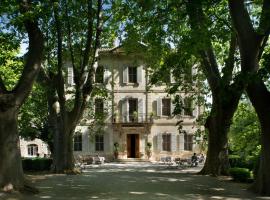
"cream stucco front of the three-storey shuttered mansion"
74,47,201,160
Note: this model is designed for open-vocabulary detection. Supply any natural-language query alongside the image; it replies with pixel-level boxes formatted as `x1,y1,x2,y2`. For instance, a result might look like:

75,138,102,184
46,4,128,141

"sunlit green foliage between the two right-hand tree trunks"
229,102,261,158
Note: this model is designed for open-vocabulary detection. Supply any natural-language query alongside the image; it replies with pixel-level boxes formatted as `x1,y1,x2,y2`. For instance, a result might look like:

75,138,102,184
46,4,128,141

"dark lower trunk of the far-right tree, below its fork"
247,79,270,195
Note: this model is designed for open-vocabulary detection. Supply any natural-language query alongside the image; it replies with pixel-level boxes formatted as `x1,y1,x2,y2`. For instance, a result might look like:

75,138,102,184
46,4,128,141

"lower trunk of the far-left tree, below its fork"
0,103,25,191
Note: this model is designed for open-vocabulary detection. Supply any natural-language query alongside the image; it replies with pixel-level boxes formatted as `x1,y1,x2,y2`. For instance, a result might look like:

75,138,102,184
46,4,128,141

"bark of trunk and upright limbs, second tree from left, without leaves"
48,0,102,172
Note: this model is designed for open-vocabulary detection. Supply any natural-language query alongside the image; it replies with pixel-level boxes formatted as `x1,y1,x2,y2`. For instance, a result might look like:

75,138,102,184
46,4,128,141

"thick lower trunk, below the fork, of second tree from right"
200,91,241,176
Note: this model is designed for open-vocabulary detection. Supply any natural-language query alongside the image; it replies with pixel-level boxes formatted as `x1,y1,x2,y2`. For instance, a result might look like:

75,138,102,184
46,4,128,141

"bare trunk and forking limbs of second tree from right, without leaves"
187,0,244,176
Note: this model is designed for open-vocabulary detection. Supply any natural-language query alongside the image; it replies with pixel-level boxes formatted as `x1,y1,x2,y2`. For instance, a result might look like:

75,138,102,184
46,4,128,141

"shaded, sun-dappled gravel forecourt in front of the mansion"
0,164,270,200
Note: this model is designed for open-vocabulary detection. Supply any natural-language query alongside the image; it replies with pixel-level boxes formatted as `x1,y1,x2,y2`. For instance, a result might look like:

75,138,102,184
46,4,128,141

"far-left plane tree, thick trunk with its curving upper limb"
0,0,43,191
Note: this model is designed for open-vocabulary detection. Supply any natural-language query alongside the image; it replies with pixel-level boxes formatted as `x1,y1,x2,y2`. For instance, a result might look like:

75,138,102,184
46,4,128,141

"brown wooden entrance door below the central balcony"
127,134,140,158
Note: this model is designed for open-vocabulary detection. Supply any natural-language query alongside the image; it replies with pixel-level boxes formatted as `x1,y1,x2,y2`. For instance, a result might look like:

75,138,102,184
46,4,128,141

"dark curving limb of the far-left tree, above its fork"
12,0,44,107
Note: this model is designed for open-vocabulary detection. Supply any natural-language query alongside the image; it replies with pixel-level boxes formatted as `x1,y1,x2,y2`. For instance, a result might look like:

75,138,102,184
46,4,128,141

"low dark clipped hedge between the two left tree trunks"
22,158,52,171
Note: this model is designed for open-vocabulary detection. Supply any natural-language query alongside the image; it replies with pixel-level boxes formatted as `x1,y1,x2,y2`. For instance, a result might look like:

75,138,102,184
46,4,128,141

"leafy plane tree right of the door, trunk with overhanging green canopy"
117,0,244,175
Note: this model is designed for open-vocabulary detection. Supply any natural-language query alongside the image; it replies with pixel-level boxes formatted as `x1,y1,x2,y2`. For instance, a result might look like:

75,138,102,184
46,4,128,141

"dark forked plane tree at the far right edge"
229,0,270,195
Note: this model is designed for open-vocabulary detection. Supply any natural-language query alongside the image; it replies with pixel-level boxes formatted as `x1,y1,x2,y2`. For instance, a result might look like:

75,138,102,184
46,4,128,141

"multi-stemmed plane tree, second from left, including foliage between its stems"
41,0,113,172
